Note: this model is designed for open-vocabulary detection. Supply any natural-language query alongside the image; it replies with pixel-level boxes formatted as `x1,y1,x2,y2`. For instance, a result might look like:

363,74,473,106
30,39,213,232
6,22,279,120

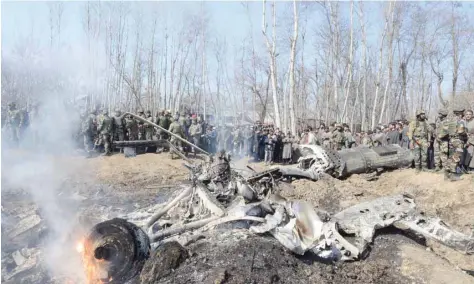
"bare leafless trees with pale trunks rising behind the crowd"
2,1,474,133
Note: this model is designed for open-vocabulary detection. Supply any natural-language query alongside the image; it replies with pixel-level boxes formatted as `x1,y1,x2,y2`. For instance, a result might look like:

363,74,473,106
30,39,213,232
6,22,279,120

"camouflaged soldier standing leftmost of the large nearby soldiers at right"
407,109,432,172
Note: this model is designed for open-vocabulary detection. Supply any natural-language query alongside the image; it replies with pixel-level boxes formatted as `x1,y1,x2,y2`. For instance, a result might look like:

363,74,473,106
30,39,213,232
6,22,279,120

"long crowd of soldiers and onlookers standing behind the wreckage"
1,103,474,179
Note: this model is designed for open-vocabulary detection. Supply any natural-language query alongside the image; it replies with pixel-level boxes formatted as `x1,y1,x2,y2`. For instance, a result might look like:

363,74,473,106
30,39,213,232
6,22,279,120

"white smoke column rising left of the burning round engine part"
1,50,91,279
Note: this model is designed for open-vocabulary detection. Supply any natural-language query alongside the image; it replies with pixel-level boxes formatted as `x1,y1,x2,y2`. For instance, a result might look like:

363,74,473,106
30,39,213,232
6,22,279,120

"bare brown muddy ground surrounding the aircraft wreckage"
2,154,474,283
